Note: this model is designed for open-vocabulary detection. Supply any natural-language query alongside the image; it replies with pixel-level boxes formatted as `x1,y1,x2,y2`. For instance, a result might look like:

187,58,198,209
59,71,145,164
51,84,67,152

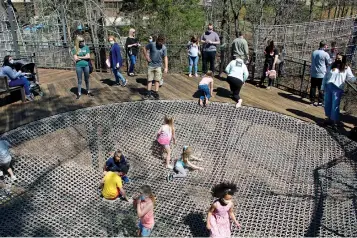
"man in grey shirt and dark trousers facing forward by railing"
201,23,221,75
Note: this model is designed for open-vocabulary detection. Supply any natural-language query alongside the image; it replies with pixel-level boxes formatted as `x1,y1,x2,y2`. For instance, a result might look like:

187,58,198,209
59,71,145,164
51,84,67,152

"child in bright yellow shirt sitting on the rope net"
101,171,129,201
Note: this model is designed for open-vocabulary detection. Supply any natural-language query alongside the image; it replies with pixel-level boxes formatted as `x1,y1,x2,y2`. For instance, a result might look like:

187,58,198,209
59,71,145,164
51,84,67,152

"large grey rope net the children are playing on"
0,101,357,236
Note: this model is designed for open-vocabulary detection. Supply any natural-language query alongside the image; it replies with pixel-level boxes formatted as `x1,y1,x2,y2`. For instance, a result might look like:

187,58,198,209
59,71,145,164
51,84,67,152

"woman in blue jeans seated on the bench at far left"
0,55,34,101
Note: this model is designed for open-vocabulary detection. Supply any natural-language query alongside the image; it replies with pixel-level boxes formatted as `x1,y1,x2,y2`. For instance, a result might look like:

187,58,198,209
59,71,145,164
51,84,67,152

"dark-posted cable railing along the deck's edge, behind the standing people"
9,39,357,115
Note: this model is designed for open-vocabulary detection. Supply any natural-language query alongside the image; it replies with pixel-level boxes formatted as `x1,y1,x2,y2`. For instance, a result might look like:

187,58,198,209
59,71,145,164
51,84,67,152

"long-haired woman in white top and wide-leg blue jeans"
321,54,356,127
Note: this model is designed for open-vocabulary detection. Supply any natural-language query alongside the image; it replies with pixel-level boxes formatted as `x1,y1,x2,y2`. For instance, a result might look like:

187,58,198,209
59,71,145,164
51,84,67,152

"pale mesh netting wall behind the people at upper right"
254,16,357,79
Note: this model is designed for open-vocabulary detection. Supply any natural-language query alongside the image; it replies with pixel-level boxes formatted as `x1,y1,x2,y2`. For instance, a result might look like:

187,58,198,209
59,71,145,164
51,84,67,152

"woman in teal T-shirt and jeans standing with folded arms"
72,36,93,99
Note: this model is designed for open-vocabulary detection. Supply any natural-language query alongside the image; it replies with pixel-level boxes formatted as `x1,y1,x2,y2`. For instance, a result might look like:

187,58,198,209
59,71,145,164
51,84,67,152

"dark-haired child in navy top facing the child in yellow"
104,150,130,183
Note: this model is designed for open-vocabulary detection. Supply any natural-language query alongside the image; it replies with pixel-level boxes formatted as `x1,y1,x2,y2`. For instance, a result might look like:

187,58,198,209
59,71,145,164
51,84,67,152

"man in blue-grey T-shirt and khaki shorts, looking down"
144,35,169,100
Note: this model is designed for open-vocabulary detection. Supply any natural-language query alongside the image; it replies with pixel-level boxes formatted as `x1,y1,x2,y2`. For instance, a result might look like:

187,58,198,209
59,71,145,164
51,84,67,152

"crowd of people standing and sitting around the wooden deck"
0,24,355,123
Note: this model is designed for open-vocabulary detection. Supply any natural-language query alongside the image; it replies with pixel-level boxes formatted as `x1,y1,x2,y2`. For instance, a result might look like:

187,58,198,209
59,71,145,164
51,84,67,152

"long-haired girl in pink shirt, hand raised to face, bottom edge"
134,185,155,237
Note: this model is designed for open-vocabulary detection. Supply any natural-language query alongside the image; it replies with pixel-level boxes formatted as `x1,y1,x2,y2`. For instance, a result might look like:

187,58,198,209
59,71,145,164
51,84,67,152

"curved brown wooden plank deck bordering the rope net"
0,69,356,133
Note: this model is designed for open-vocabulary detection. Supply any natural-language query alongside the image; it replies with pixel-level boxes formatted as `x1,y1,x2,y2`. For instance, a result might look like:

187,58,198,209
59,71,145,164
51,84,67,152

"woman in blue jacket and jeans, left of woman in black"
108,36,126,87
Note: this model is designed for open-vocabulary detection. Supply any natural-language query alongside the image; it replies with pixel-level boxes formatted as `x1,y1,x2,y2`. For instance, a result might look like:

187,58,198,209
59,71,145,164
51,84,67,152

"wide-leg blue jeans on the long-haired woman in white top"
324,83,343,122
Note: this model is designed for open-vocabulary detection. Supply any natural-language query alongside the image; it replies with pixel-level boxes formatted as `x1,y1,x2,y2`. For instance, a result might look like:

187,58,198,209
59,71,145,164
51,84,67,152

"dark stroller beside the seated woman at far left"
14,60,44,97
